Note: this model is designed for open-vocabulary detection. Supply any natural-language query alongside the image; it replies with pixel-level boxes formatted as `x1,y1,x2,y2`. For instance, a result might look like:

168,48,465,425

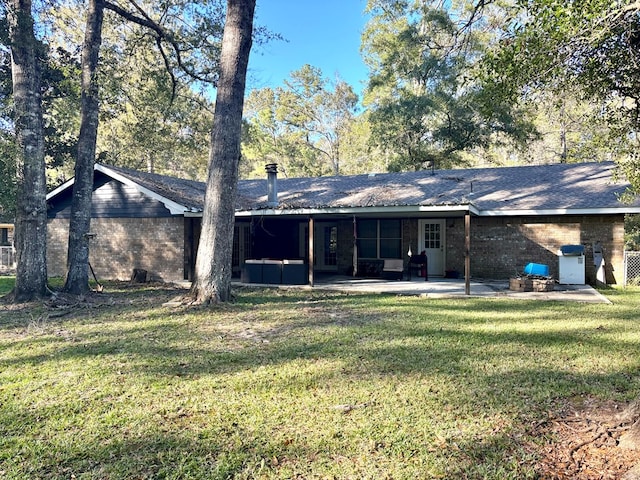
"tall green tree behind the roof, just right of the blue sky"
363,0,533,170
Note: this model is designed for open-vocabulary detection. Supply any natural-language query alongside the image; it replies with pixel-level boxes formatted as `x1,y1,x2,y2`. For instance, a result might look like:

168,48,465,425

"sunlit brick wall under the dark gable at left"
47,217,184,282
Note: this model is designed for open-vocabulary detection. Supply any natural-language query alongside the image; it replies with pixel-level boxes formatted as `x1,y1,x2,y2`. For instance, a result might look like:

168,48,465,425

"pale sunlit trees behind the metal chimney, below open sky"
244,65,358,176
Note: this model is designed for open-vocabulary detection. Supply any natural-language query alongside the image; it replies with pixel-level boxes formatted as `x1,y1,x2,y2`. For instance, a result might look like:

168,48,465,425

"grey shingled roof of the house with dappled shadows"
53,162,640,215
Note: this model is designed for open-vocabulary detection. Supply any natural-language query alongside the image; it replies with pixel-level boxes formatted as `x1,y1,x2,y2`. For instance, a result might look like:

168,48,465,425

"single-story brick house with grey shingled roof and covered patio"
47,162,640,284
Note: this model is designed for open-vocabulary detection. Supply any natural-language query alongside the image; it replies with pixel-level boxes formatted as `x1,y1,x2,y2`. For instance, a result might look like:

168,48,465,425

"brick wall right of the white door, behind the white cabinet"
446,215,624,284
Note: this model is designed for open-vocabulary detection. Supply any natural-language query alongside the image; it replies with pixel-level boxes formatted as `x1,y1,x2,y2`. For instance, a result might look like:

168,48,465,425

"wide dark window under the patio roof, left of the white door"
358,219,402,258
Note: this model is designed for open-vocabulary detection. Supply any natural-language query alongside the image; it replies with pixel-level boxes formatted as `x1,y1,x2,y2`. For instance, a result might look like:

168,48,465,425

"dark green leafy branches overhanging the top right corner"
483,0,640,186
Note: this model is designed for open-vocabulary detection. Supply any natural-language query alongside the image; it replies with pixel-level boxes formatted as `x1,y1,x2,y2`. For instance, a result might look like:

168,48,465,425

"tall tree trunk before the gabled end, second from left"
64,0,104,295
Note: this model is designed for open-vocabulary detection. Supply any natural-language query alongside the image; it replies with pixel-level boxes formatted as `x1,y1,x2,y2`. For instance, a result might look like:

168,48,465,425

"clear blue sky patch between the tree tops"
247,0,367,97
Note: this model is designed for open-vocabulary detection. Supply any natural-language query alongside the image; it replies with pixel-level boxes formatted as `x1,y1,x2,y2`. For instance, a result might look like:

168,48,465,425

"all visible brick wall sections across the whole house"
47,215,624,284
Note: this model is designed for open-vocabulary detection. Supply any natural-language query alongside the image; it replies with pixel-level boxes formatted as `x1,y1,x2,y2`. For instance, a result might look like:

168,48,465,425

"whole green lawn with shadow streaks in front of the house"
0,278,640,479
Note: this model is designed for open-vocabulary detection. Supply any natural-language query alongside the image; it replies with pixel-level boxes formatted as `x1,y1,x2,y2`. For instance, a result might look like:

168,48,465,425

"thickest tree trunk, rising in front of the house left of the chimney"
191,0,256,303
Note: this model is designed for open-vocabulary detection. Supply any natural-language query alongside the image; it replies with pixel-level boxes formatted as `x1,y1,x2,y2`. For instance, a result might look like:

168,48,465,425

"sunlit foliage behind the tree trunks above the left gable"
0,0,231,192
